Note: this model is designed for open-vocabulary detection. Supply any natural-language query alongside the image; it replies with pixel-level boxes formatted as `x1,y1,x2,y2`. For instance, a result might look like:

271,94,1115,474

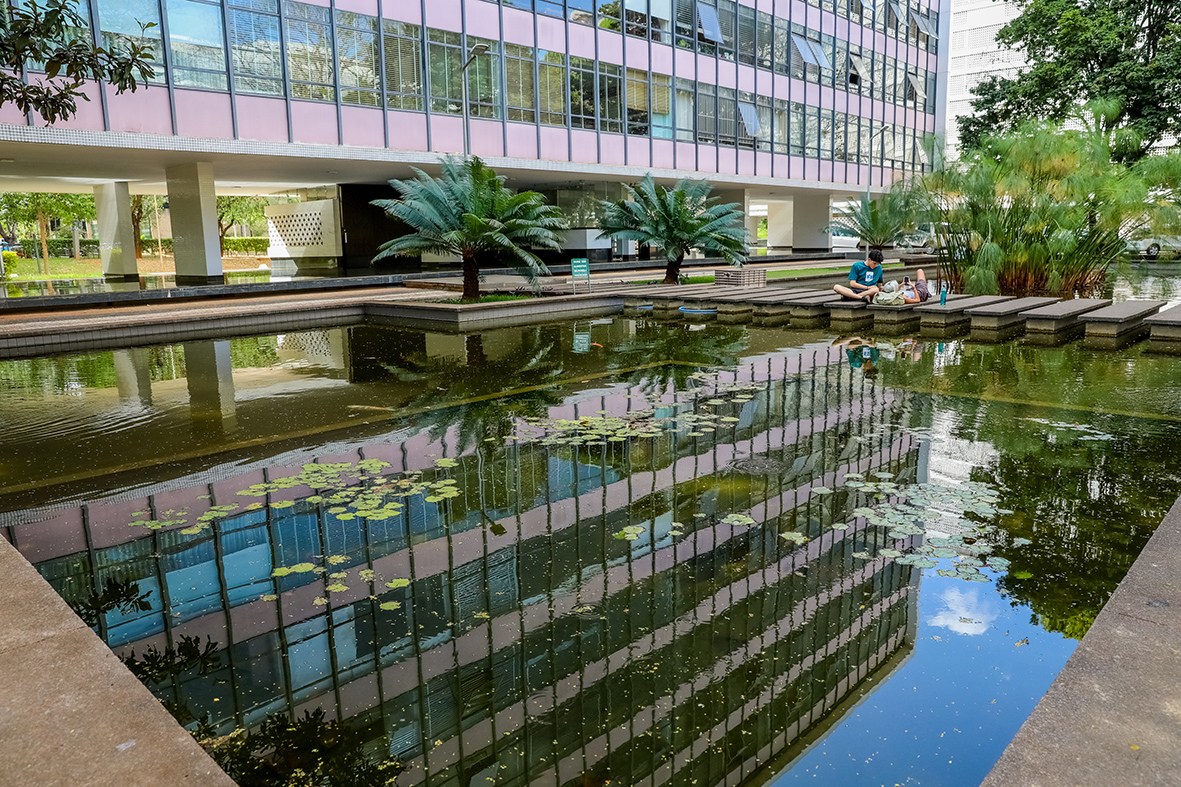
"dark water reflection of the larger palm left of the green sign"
386,330,563,453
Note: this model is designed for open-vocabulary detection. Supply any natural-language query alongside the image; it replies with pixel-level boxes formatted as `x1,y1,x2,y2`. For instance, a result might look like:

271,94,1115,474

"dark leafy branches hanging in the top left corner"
0,0,155,125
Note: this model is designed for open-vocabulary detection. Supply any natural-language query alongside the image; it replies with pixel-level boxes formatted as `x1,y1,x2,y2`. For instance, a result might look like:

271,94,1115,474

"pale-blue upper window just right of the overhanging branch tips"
168,0,228,90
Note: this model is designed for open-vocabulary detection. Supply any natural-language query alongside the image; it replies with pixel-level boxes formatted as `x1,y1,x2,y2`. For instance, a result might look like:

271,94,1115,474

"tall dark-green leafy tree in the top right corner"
959,0,1181,162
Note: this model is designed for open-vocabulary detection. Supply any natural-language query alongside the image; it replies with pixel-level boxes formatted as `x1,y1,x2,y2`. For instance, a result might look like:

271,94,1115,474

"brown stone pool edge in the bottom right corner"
981,499,1181,787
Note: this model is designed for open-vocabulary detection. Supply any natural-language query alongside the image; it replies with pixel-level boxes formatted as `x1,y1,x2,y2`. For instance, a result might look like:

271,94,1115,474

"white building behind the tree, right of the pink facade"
945,0,1026,158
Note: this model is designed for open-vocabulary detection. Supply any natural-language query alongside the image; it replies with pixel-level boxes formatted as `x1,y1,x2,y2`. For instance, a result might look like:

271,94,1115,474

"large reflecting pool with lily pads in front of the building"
0,318,1181,786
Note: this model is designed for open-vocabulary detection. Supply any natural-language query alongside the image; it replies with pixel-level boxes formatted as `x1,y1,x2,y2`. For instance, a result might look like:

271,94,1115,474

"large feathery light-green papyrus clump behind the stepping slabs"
926,116,1181,297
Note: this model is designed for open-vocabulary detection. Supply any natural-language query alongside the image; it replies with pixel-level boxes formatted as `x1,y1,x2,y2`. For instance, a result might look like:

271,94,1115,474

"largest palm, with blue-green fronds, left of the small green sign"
373,157,566,300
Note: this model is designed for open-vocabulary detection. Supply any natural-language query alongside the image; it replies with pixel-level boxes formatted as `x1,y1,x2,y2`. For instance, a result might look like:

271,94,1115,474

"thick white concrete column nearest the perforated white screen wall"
164,161,223,284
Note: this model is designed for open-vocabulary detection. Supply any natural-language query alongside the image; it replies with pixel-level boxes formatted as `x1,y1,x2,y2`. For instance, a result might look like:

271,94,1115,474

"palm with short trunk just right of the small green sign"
599,175,746,284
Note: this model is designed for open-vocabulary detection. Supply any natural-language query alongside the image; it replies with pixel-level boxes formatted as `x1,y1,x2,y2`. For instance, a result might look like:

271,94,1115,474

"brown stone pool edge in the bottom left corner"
0,538,234,787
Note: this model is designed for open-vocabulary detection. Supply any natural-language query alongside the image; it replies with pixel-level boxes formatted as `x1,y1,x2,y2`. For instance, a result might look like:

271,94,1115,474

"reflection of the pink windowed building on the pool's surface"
8,350,918,785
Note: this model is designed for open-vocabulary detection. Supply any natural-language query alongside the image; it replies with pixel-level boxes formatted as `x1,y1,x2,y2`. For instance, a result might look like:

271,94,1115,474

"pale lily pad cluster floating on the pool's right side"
813,473,1027,583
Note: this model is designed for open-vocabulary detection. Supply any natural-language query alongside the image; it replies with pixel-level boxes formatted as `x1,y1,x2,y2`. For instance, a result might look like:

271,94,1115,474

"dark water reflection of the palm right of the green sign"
611,320,748,396
